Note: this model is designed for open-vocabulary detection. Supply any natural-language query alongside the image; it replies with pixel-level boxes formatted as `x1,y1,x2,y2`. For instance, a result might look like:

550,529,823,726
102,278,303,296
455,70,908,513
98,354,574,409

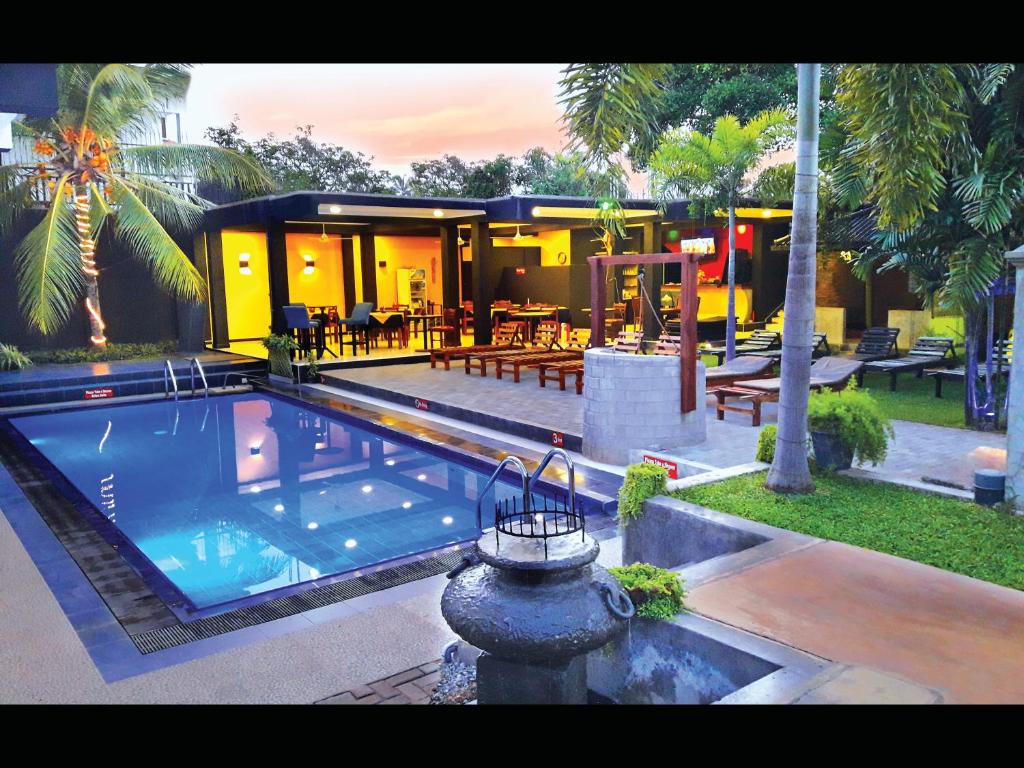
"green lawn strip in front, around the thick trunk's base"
672,472,1024,590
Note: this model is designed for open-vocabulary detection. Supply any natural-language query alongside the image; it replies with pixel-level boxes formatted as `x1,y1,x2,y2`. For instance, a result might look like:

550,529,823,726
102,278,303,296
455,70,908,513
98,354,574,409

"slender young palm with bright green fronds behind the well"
649,110,792,360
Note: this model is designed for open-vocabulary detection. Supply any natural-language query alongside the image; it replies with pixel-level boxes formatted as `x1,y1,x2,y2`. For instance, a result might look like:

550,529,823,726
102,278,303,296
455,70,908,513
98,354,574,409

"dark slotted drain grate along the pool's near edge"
131,550,463,653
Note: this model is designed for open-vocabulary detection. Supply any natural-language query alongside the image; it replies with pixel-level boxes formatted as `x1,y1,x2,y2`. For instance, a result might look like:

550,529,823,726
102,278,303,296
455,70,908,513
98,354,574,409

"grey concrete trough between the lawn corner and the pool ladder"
620,496,767,568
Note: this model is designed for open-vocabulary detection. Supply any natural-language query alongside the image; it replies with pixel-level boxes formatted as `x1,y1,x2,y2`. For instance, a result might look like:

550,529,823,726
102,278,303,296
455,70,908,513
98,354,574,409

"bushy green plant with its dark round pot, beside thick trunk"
807,382,893,470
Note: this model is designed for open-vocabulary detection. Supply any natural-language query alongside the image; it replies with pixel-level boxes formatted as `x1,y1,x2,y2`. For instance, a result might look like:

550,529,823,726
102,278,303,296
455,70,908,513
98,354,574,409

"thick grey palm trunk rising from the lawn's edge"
765,65,821,493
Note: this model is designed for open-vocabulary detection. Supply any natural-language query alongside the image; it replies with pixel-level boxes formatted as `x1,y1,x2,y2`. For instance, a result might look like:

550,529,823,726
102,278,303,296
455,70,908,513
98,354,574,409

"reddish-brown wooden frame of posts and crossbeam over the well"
587,253,700,414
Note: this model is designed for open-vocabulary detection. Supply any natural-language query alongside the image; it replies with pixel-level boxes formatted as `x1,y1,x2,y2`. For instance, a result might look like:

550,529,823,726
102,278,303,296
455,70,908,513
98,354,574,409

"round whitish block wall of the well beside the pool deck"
583,347,707,464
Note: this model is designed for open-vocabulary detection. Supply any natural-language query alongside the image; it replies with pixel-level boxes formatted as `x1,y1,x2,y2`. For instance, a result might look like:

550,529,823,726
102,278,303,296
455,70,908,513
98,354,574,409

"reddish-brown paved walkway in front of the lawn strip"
687,542,1024,703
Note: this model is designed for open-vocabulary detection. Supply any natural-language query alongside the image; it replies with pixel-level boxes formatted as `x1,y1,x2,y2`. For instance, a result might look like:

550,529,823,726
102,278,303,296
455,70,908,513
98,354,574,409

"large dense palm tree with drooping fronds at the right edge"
835,63,1024,424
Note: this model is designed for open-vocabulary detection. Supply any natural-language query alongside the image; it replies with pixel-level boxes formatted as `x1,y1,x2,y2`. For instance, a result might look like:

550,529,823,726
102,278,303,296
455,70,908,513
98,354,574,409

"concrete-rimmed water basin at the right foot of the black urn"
587,614,823,705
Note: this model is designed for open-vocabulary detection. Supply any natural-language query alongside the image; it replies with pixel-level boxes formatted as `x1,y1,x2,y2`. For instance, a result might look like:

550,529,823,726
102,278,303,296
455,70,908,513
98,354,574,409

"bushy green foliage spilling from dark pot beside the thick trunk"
807,381,894,465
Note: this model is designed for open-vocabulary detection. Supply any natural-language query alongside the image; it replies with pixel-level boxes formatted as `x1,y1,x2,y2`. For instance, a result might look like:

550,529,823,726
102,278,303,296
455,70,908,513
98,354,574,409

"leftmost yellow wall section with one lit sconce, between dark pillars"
222,229,270,339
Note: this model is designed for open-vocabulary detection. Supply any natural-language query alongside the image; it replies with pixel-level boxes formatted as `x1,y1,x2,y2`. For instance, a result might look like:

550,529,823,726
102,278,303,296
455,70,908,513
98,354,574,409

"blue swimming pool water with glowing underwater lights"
10,393,528,608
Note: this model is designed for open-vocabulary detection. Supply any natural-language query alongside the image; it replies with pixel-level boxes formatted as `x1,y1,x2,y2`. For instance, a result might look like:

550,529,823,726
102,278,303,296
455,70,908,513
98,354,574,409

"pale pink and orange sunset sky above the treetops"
183,63,655,188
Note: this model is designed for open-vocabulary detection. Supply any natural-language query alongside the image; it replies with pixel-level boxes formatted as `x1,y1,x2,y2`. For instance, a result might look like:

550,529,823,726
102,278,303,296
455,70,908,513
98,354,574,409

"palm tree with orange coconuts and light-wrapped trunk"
0,63,270,346
